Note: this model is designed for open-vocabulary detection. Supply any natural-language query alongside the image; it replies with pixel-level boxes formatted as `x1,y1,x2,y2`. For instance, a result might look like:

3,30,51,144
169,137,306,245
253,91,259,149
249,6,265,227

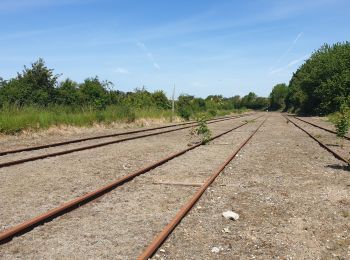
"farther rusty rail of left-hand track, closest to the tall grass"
0,113,252,156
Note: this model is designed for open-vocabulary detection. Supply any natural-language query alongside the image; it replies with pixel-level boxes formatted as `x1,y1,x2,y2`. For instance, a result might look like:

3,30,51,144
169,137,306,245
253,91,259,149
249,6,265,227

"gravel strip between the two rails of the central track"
0,115,257,259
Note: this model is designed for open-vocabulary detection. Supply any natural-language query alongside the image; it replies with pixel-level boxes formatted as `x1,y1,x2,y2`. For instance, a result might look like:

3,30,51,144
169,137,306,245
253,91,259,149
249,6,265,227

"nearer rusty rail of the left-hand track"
0,114,253,168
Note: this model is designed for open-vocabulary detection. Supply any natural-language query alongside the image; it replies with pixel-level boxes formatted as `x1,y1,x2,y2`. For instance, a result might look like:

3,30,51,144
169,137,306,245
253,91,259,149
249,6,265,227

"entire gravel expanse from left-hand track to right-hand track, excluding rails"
0,113,350,259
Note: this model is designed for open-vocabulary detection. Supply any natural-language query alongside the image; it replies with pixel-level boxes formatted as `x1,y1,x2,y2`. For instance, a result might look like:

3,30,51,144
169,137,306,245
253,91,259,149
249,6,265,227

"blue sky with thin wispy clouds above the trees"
0,0,350,97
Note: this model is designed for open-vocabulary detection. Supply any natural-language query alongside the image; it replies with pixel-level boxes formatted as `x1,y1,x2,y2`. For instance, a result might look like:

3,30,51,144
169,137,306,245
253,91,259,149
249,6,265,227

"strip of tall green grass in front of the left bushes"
0,105,245,134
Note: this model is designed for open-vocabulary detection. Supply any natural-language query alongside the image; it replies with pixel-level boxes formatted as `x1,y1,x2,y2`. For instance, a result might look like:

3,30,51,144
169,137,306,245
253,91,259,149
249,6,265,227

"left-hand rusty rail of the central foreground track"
0,116,262,244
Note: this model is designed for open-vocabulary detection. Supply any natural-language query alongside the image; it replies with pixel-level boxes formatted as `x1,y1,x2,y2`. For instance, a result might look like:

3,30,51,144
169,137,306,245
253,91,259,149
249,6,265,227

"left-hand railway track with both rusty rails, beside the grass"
0,114,251,168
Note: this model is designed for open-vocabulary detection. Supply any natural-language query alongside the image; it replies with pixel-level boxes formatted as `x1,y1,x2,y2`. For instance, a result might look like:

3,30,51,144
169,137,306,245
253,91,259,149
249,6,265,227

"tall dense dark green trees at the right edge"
270,42,350,115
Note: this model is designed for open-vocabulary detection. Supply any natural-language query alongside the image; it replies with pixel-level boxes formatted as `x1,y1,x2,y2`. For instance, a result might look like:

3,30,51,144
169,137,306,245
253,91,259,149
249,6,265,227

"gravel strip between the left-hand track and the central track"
0,116,253,233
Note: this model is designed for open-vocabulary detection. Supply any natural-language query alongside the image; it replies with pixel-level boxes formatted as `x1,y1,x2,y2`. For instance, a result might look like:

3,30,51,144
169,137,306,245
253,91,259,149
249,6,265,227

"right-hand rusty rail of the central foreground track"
138,118,267,260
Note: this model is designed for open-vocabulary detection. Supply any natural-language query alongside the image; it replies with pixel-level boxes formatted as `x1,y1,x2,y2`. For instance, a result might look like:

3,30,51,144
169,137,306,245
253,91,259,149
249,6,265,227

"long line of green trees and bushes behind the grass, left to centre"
0,59,269,119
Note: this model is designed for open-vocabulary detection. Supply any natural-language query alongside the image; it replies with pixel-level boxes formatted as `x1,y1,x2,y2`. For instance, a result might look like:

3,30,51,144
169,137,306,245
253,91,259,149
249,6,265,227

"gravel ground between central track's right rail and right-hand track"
154,114,350,259
